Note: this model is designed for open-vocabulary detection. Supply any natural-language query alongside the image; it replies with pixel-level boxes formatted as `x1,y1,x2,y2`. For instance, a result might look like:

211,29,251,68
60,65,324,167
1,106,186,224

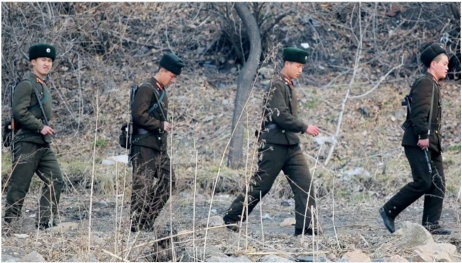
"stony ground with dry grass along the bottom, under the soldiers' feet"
2,187,461,262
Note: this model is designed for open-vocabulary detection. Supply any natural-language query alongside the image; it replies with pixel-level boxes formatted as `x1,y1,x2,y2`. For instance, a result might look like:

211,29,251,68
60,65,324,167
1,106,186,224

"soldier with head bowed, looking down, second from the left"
130,53,185,232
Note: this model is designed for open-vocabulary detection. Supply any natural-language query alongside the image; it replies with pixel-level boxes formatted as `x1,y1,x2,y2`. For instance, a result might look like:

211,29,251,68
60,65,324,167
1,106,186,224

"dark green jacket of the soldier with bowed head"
132,77,168,150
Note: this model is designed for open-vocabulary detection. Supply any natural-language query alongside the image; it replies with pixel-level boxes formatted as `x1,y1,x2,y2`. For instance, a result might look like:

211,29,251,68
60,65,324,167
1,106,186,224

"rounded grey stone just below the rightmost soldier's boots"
399,221,434,248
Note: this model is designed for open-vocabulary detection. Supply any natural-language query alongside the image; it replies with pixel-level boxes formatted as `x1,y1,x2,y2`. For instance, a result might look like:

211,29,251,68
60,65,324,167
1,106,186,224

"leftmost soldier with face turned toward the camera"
4,44,64,229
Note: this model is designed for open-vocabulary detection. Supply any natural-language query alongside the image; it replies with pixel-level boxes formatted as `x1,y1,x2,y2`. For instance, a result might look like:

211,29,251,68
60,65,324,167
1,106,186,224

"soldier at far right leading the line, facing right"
379,44,451,235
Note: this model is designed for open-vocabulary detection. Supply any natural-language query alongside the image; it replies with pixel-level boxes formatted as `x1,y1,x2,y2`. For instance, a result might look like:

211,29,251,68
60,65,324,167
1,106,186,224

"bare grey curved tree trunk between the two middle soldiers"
228,2,261,169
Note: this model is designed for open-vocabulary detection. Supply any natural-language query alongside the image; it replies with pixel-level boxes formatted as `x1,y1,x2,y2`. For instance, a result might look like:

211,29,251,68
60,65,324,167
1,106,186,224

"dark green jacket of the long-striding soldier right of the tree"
259,74,308,145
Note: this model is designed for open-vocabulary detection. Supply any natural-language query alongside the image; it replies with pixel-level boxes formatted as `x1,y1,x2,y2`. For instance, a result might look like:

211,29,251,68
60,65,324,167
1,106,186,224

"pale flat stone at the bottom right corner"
412,243,457,262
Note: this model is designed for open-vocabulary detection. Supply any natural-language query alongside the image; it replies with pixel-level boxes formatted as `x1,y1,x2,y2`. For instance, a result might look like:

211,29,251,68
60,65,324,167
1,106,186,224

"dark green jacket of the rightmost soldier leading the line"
401,73,442,152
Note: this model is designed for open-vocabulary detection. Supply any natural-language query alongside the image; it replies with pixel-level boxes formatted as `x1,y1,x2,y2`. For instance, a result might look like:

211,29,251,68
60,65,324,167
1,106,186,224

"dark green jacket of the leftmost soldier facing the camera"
13,72,51,144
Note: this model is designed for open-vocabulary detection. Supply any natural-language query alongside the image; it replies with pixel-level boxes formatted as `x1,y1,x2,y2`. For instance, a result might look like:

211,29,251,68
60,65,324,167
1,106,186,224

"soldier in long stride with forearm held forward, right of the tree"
223,48,319,235
